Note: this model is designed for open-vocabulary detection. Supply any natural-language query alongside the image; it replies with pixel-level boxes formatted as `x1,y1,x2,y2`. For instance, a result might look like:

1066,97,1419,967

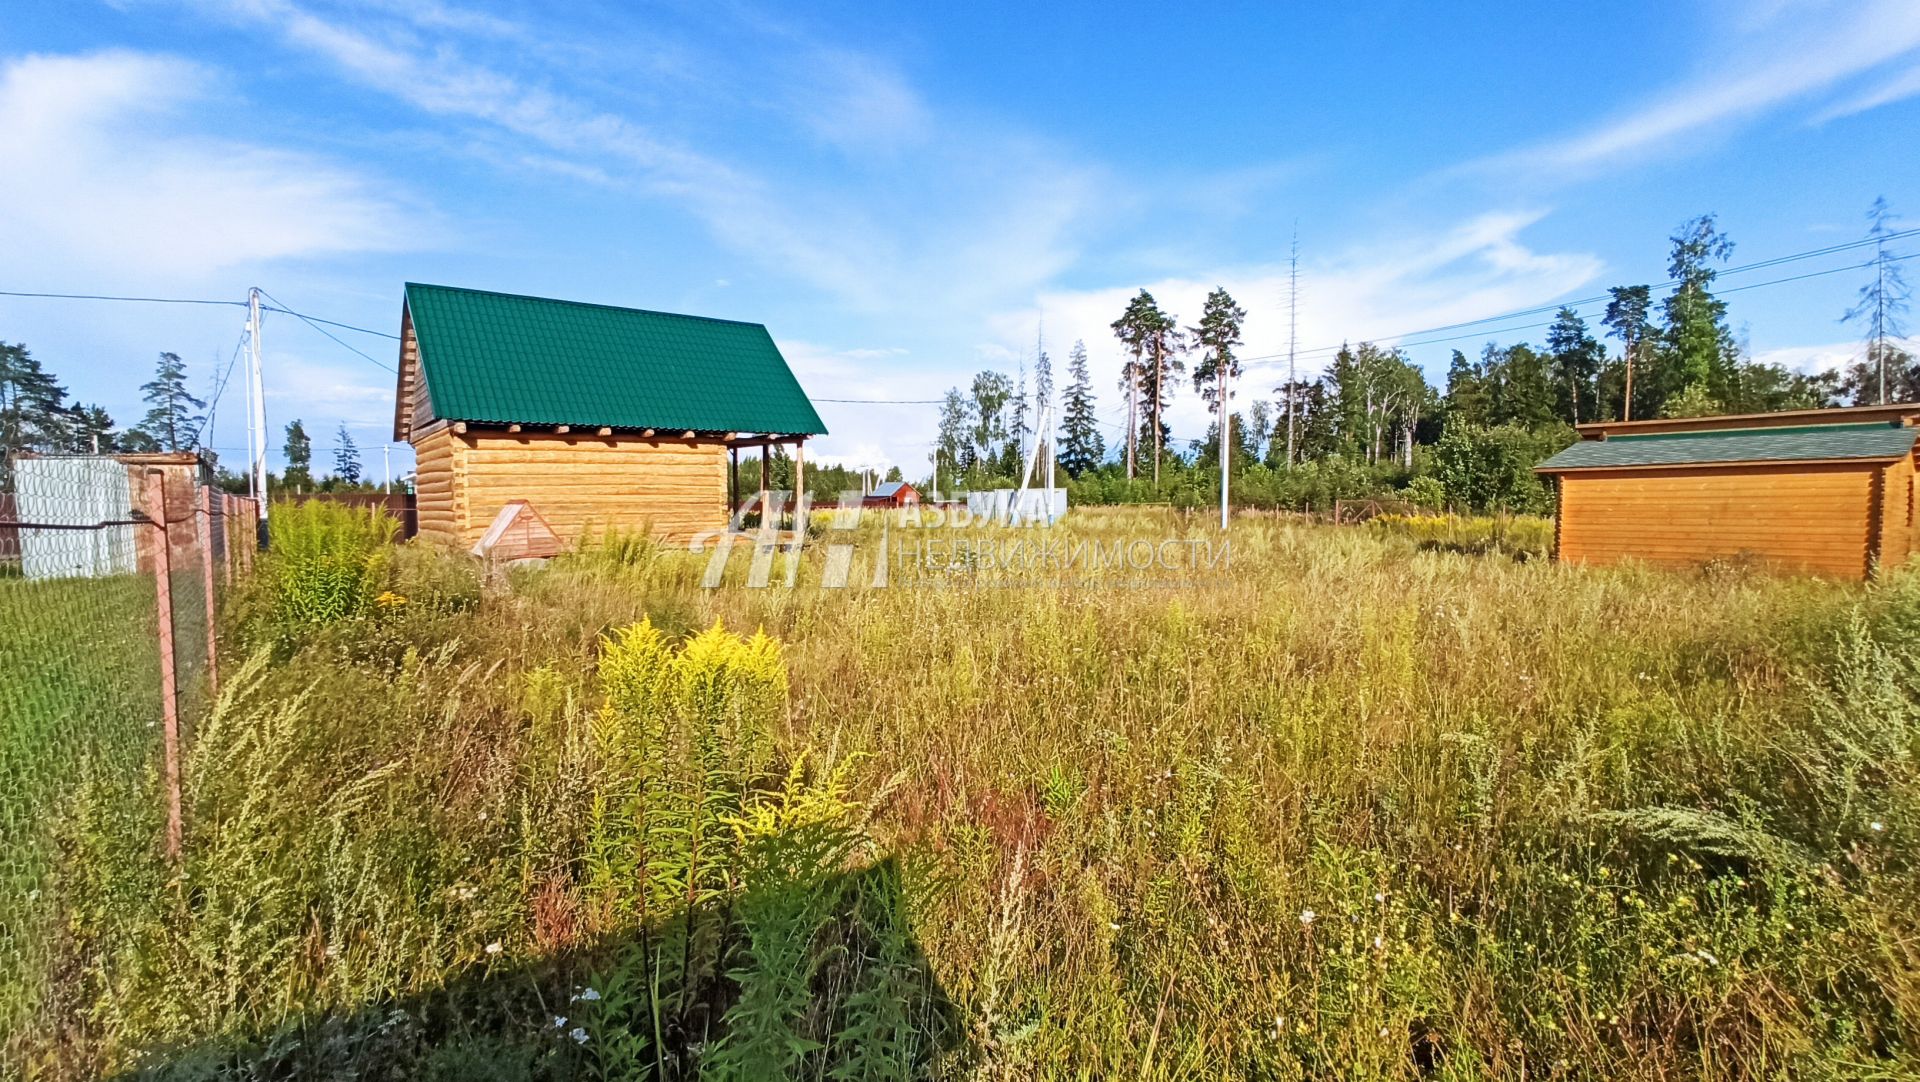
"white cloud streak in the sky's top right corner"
1469,0,1920,173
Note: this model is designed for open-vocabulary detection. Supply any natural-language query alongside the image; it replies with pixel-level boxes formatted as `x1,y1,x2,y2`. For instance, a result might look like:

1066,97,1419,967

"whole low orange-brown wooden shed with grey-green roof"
1538,403,1920,579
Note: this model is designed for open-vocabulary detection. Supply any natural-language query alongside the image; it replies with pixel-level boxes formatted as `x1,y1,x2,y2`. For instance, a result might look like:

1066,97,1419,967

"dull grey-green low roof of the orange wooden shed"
1536,424,1920,474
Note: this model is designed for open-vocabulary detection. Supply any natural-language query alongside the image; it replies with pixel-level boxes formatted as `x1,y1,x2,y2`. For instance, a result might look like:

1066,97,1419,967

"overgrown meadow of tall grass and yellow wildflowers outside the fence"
6,505,1920,1080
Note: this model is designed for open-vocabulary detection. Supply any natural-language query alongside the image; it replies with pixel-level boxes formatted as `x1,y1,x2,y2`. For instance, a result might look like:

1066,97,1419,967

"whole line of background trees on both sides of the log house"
0,210,1920,514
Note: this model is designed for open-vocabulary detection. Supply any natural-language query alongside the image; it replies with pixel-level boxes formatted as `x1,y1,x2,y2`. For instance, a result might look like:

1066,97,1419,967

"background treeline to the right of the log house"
927,210,1920,512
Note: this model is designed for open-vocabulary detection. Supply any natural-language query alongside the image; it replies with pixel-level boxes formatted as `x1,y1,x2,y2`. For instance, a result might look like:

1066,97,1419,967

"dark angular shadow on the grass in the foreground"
117,858,972,1082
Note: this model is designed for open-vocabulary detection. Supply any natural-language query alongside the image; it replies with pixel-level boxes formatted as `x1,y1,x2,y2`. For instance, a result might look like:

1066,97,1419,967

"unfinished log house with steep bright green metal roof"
394,282,826,547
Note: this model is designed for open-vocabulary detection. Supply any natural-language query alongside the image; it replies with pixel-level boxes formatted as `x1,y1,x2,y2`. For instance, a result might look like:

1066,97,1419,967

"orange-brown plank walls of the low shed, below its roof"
1559,462,1873,579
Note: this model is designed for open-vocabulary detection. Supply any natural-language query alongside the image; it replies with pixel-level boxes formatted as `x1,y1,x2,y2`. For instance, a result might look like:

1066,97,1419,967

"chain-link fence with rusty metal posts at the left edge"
0,455,257,1032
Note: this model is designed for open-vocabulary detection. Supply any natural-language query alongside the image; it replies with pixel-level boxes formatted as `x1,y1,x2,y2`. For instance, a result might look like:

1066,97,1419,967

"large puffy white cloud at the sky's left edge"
0,52,417,284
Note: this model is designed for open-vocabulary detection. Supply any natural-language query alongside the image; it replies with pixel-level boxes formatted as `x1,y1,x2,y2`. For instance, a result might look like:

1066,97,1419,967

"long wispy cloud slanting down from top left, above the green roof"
191,0,1098,311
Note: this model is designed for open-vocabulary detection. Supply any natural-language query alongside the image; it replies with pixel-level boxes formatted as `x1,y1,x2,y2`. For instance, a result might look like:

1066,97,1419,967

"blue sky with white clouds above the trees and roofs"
0,0,1920,472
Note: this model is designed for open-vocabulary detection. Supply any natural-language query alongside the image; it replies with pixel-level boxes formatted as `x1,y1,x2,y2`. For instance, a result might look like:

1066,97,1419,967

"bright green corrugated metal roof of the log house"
407,282,828,435
